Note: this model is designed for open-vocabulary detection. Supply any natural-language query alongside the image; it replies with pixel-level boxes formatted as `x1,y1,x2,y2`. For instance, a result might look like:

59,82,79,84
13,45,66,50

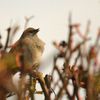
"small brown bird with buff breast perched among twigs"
10,28,45,70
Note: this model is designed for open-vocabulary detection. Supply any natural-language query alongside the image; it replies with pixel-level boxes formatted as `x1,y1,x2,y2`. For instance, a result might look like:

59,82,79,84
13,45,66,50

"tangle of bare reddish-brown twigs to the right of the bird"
51,13,100,100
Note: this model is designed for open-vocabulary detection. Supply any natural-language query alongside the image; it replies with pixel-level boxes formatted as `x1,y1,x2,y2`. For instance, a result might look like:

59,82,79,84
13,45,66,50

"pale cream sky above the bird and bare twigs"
0,0,100,99
